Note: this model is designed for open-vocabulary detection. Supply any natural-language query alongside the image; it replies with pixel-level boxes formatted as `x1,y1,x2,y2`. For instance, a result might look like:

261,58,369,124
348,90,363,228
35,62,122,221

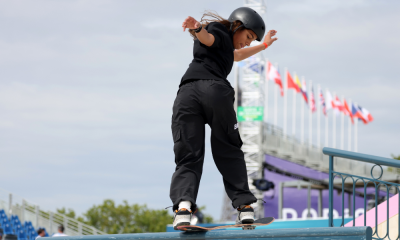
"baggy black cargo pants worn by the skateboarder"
170,80,257,210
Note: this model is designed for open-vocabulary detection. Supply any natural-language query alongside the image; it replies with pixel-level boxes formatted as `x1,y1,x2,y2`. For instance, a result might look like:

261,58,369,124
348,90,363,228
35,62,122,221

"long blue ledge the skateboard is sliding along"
49,227,372,240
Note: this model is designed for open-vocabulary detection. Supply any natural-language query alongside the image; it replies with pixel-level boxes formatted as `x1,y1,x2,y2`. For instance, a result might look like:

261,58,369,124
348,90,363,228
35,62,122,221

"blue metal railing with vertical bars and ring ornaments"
322,148,400,239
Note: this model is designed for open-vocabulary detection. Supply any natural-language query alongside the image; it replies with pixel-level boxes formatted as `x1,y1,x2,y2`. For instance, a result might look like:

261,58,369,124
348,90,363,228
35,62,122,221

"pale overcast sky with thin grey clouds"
0,0,400,219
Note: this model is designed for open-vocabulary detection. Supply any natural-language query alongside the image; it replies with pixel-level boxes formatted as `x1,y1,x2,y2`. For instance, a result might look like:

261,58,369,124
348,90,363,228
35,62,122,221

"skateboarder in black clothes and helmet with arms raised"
170,7,277,229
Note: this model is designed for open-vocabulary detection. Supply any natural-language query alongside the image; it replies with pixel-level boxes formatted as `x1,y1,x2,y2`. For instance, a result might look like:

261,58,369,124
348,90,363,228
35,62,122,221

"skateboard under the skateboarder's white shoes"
177,217,275,232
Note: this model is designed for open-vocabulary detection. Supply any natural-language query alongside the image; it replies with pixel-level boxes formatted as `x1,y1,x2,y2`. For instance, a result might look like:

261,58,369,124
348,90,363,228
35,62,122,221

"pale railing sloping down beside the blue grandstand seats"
0,189,107,236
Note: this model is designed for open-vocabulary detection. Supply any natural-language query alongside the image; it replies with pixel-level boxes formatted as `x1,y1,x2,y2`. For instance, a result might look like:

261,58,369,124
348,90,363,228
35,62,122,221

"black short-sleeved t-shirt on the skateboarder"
179,22,234,86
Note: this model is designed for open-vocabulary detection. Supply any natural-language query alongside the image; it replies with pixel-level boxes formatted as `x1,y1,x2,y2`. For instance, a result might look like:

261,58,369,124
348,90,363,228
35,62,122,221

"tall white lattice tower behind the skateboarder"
222,0,266,221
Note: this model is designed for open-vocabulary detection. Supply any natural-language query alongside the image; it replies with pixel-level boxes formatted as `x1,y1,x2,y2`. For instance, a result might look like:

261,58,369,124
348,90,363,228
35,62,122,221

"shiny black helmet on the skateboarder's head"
228,7,265,41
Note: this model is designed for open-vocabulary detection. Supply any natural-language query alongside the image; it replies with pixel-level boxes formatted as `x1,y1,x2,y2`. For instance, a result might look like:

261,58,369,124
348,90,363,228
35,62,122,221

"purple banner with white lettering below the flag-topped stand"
264,155,374,219
